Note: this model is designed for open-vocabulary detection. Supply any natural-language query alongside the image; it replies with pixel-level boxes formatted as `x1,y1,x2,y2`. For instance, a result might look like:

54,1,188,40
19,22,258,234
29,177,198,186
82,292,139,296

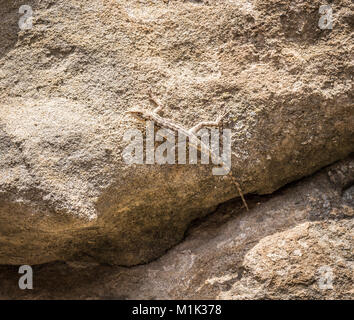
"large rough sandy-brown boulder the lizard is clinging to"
0,0,354,264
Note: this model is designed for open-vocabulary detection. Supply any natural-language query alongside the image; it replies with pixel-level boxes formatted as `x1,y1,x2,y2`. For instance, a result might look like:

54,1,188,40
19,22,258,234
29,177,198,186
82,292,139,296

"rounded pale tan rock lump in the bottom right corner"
218,219,354,299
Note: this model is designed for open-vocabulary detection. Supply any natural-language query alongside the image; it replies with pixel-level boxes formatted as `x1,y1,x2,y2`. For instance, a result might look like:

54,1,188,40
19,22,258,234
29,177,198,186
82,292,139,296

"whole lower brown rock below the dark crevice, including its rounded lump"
0,158,354,299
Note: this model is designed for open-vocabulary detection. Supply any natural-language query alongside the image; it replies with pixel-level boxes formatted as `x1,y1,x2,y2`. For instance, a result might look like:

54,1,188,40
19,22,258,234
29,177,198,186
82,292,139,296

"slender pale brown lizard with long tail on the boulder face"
126,92,249,211
